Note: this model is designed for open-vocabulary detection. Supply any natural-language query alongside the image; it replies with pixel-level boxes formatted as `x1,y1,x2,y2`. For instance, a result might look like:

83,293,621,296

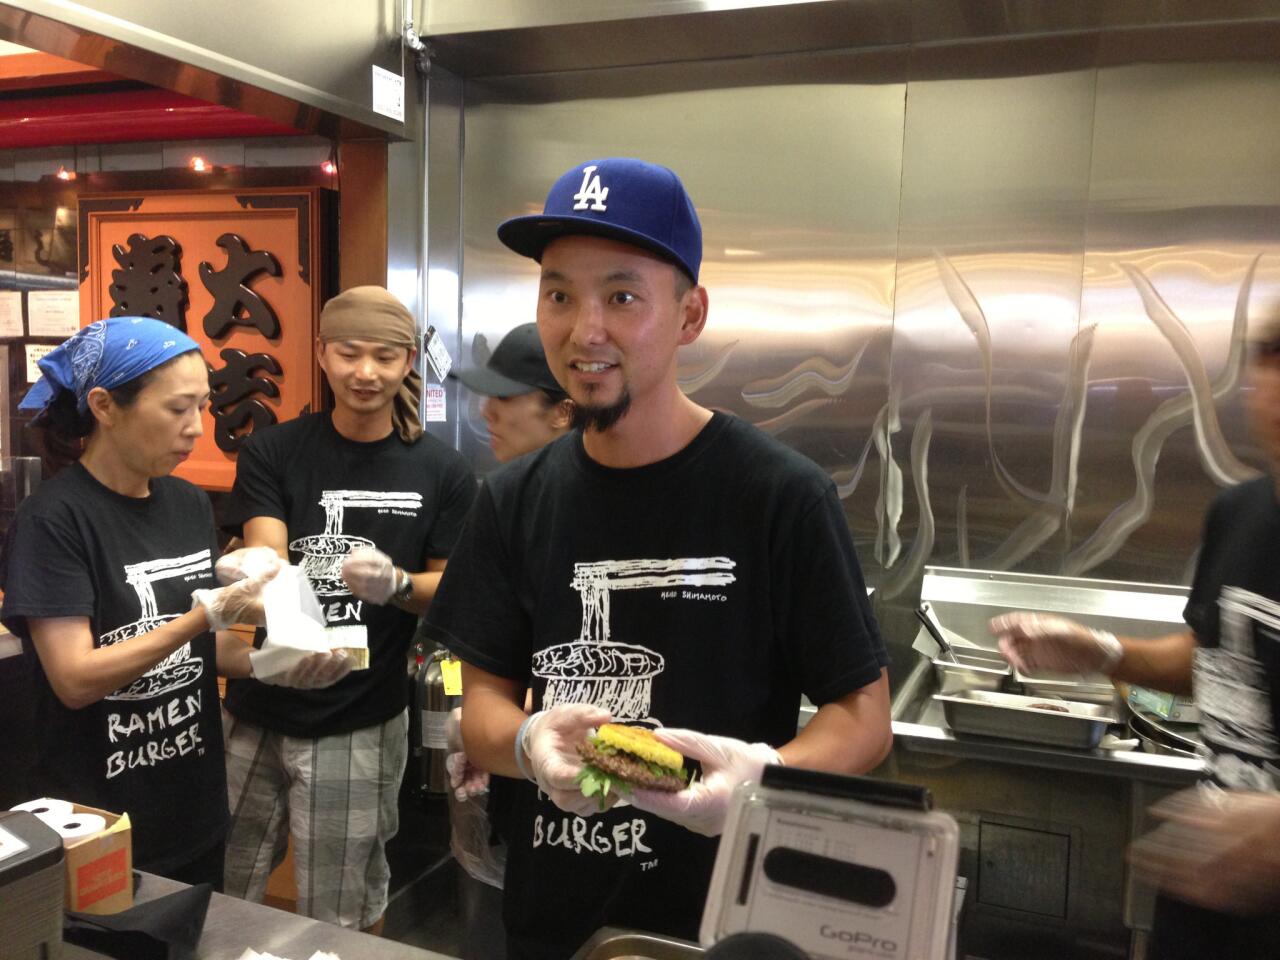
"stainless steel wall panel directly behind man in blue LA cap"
462,54,906,572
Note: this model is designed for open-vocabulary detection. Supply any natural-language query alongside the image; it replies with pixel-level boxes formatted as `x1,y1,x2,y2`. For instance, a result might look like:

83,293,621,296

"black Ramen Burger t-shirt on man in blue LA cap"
428,413,886,957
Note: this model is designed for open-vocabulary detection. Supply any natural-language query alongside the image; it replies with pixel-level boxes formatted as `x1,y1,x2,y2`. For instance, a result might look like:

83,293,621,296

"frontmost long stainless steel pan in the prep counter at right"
933,690,1119,749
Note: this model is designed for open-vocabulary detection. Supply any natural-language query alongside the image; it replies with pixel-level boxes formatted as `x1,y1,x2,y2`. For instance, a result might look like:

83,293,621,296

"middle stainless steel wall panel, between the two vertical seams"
881,38,1094,599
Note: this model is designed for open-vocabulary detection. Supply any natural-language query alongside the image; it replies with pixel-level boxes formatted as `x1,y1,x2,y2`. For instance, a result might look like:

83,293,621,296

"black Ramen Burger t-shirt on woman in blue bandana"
0,463,227,873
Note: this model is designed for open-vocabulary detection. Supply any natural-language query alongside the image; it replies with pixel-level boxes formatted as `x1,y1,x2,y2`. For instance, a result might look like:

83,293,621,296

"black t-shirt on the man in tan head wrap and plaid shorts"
225,413,476,737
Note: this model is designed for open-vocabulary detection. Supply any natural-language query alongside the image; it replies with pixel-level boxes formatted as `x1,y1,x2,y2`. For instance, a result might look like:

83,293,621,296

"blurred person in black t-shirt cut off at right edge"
992,315,1280,960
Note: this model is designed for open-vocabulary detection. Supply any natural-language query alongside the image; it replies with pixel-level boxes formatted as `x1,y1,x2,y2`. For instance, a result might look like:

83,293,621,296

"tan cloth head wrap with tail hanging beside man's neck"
320,287,422,443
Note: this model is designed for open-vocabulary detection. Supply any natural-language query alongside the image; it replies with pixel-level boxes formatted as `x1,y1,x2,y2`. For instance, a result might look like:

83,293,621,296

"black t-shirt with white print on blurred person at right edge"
1149,476,1280,960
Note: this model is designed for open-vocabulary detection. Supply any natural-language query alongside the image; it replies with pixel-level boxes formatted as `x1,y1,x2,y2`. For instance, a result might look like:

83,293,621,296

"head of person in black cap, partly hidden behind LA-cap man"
449,324,573,463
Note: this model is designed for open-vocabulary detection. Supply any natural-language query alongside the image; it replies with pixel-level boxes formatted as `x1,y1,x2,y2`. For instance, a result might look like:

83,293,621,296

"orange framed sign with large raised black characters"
78,188,325,490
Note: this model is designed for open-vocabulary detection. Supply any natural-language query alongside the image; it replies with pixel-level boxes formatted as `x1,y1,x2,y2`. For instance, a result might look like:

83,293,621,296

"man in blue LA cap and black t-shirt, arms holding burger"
428,157,891,960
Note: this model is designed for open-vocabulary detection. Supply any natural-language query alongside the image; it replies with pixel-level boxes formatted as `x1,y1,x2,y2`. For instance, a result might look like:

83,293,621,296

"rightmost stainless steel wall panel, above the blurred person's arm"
1062,52,1280,582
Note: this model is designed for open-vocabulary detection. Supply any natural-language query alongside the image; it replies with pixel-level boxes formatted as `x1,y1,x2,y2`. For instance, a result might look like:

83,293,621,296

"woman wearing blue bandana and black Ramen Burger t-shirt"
0,317,349,887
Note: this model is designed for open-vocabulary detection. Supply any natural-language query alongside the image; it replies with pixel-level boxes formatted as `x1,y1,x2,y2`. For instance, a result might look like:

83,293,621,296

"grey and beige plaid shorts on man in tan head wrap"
223,710,408,929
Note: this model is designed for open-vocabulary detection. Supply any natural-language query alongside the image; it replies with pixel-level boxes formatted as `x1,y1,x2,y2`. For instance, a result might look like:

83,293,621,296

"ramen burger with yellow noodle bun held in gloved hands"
576,723,689,810
